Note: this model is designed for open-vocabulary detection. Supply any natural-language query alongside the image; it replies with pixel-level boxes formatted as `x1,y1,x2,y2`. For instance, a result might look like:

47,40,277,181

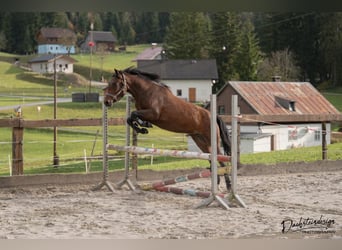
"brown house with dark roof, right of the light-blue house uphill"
81,31,117,52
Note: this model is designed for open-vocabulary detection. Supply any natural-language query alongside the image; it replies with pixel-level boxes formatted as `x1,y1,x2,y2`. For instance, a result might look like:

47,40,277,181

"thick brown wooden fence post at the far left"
12,119,24,175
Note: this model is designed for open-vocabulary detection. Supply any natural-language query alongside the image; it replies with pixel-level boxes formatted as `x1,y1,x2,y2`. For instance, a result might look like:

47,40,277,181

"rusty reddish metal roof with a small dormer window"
222,81,340,115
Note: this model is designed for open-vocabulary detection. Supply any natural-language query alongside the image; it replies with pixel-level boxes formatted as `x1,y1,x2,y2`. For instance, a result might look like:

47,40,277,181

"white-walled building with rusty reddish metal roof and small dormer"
217,81,341,153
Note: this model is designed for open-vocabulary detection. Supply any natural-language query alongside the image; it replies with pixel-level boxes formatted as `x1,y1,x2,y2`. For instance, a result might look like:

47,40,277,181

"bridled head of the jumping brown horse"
103,69,127,107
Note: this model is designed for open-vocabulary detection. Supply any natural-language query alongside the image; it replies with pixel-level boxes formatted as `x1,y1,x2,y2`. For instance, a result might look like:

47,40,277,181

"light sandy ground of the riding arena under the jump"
0,162,342,239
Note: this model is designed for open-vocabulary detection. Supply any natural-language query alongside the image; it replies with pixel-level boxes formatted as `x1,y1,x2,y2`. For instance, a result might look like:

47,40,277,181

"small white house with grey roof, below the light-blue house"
28,54,77,74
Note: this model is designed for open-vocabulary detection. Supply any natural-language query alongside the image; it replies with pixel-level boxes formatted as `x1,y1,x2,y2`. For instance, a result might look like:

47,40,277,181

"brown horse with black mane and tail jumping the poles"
104,68,230,190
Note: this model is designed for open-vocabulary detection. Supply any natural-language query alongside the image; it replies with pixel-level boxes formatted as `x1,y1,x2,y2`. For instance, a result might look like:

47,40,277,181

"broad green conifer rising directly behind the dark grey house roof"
164,12,209,59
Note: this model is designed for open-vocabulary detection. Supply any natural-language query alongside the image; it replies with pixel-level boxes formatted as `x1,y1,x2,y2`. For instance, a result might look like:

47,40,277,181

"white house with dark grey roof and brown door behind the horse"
137,59,218,102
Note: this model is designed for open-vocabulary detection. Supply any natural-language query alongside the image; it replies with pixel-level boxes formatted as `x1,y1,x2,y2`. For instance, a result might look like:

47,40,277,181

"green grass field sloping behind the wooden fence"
0,45,342,175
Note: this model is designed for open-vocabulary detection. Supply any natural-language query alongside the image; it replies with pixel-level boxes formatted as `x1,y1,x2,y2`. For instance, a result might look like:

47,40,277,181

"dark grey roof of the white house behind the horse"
137,59,218,80
